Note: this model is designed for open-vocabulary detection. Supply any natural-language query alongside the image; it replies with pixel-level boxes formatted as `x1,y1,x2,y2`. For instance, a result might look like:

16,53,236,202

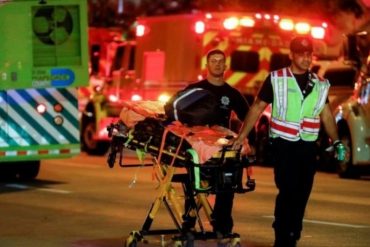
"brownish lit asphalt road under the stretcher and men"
0,151,370,247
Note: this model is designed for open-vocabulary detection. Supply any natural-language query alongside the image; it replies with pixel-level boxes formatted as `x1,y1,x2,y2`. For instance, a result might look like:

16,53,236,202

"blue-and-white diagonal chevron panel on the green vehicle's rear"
0,88,80,157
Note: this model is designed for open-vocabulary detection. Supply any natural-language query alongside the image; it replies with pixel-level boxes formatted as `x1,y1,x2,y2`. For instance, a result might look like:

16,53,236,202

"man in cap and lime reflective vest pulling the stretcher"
233,36,342,247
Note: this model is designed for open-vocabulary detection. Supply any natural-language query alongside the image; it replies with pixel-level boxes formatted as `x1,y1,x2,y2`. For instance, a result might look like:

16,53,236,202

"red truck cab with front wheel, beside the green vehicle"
78,27,137,155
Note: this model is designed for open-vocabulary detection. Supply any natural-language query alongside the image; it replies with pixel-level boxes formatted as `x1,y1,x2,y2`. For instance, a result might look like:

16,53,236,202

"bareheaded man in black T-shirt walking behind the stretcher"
184,49,249,235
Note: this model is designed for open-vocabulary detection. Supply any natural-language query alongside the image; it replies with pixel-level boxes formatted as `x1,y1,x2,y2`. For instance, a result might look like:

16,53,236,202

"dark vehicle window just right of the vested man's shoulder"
324,68,356,87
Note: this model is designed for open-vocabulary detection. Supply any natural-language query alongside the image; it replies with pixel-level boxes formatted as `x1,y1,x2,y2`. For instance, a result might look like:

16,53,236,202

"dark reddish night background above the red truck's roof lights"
88,0,370,34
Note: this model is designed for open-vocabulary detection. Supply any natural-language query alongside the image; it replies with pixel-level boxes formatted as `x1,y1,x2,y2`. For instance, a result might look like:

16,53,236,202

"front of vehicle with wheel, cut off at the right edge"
335,32,370,178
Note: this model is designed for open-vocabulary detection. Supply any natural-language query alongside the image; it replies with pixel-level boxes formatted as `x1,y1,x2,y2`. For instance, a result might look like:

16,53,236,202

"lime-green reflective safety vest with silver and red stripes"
270,68,329,141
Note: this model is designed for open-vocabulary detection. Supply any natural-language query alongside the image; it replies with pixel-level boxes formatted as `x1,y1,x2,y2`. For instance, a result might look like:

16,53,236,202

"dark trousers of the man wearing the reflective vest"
272,138,316,244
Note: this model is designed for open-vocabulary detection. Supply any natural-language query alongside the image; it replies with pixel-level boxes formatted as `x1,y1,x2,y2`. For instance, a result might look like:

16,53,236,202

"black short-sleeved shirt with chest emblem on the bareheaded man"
186,79,249,128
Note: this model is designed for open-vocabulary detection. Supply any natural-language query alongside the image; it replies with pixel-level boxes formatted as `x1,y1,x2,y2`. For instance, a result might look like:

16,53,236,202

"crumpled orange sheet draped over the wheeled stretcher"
120,101,250,164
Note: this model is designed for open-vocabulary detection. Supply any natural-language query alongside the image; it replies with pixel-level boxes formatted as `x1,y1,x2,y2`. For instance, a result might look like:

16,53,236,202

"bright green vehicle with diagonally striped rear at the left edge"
0,0,89,179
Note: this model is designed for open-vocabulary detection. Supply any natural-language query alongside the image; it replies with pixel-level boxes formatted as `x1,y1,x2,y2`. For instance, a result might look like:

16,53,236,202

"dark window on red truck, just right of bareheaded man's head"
230,51,259,73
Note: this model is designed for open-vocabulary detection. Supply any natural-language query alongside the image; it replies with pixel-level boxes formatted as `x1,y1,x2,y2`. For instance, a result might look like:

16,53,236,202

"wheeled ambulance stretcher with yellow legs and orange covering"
107,101,255,247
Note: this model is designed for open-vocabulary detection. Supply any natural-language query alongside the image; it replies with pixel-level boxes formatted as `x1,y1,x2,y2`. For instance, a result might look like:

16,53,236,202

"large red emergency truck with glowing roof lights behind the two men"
82,12,340,154
